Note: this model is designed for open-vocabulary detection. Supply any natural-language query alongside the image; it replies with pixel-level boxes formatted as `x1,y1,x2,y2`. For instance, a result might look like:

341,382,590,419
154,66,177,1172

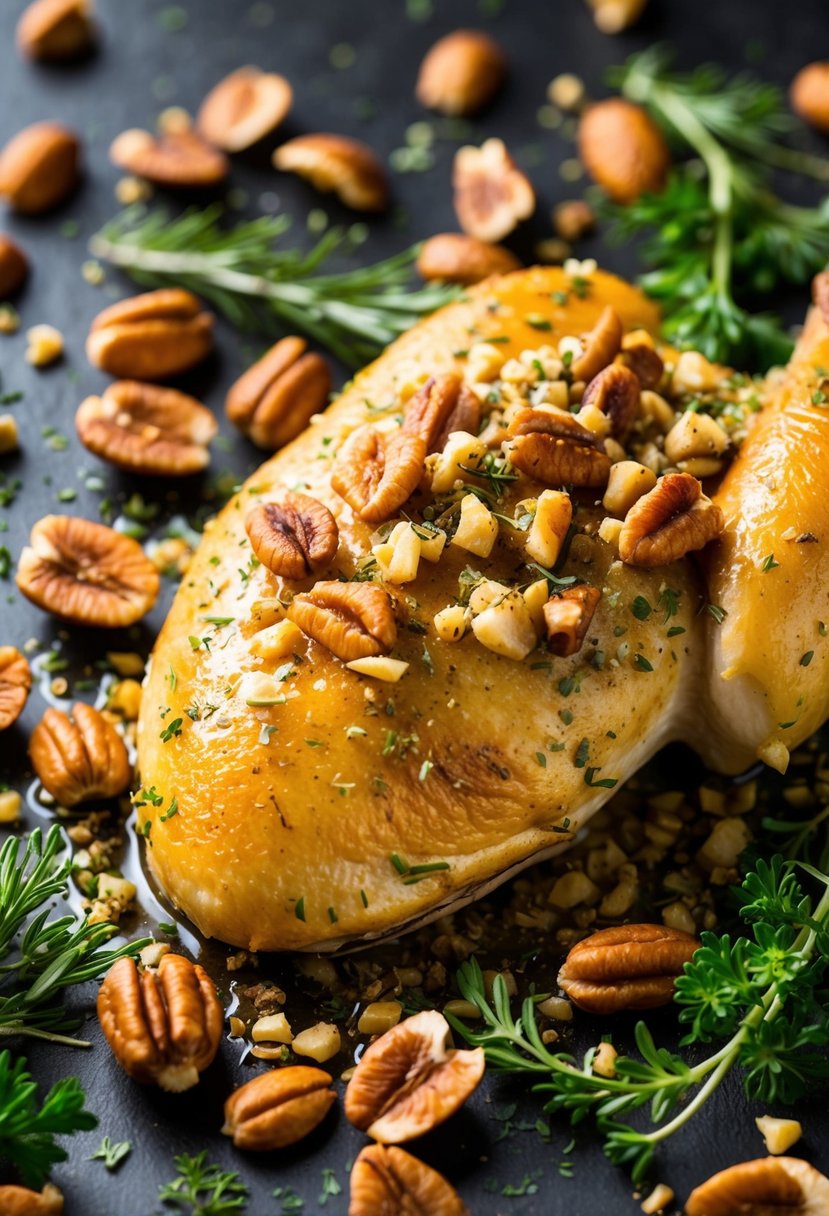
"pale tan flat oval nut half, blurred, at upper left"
196,67,294,152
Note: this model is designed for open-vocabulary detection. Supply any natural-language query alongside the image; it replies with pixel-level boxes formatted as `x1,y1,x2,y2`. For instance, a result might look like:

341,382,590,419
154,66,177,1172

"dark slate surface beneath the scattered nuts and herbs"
0,0,829,1216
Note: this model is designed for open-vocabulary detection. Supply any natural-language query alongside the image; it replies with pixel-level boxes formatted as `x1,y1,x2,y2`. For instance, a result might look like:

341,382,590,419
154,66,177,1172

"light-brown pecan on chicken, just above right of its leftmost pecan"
331,423,425,524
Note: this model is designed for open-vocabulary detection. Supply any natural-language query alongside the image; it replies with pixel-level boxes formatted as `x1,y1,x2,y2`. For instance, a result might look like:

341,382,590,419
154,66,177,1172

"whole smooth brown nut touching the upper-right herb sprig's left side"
579,97,671,203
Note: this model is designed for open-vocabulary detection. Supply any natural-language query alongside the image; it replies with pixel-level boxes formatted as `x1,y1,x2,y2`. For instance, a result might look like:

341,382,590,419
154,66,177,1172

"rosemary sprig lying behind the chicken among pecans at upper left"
90,206,458,366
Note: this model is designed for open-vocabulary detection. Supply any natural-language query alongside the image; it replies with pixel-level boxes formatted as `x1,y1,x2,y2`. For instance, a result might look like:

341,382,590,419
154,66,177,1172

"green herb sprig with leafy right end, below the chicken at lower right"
447,855,829,1182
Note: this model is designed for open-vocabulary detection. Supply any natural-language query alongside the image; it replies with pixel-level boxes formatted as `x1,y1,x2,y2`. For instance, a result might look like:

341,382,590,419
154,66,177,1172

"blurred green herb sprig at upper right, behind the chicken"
602,47,829,371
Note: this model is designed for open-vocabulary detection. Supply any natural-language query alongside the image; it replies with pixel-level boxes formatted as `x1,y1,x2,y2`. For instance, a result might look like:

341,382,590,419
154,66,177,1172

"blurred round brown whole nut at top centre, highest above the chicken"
415,29,507,116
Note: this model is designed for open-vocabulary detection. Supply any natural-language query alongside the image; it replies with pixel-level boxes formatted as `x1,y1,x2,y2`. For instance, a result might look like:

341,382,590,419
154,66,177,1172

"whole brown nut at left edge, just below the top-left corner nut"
0,123,80,215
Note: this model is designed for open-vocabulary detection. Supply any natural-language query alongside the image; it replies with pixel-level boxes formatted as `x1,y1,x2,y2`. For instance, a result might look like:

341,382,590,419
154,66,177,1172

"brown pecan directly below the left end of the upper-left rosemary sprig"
86,287,213,381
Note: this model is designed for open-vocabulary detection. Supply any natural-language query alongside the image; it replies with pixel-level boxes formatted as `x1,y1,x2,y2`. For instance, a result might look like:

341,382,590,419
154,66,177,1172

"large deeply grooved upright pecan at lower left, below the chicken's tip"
97,955,224,1093
